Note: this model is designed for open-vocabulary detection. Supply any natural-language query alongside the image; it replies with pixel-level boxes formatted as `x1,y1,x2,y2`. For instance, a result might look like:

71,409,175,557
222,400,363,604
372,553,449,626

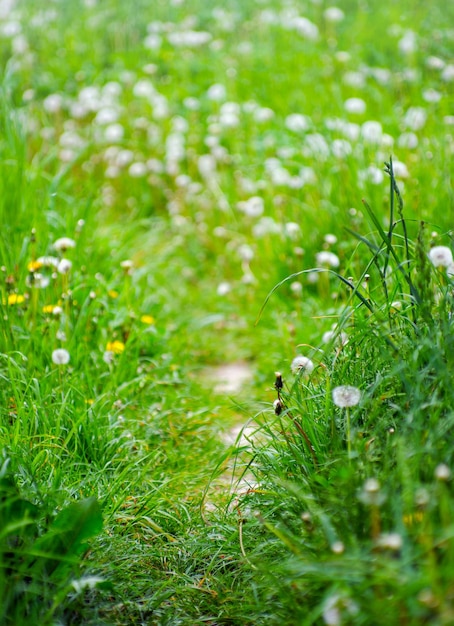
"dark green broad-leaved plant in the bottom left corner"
0,450,103,624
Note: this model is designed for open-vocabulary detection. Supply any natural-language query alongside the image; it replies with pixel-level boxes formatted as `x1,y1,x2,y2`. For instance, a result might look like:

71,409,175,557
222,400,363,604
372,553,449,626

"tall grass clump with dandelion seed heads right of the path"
232,162,454,624
